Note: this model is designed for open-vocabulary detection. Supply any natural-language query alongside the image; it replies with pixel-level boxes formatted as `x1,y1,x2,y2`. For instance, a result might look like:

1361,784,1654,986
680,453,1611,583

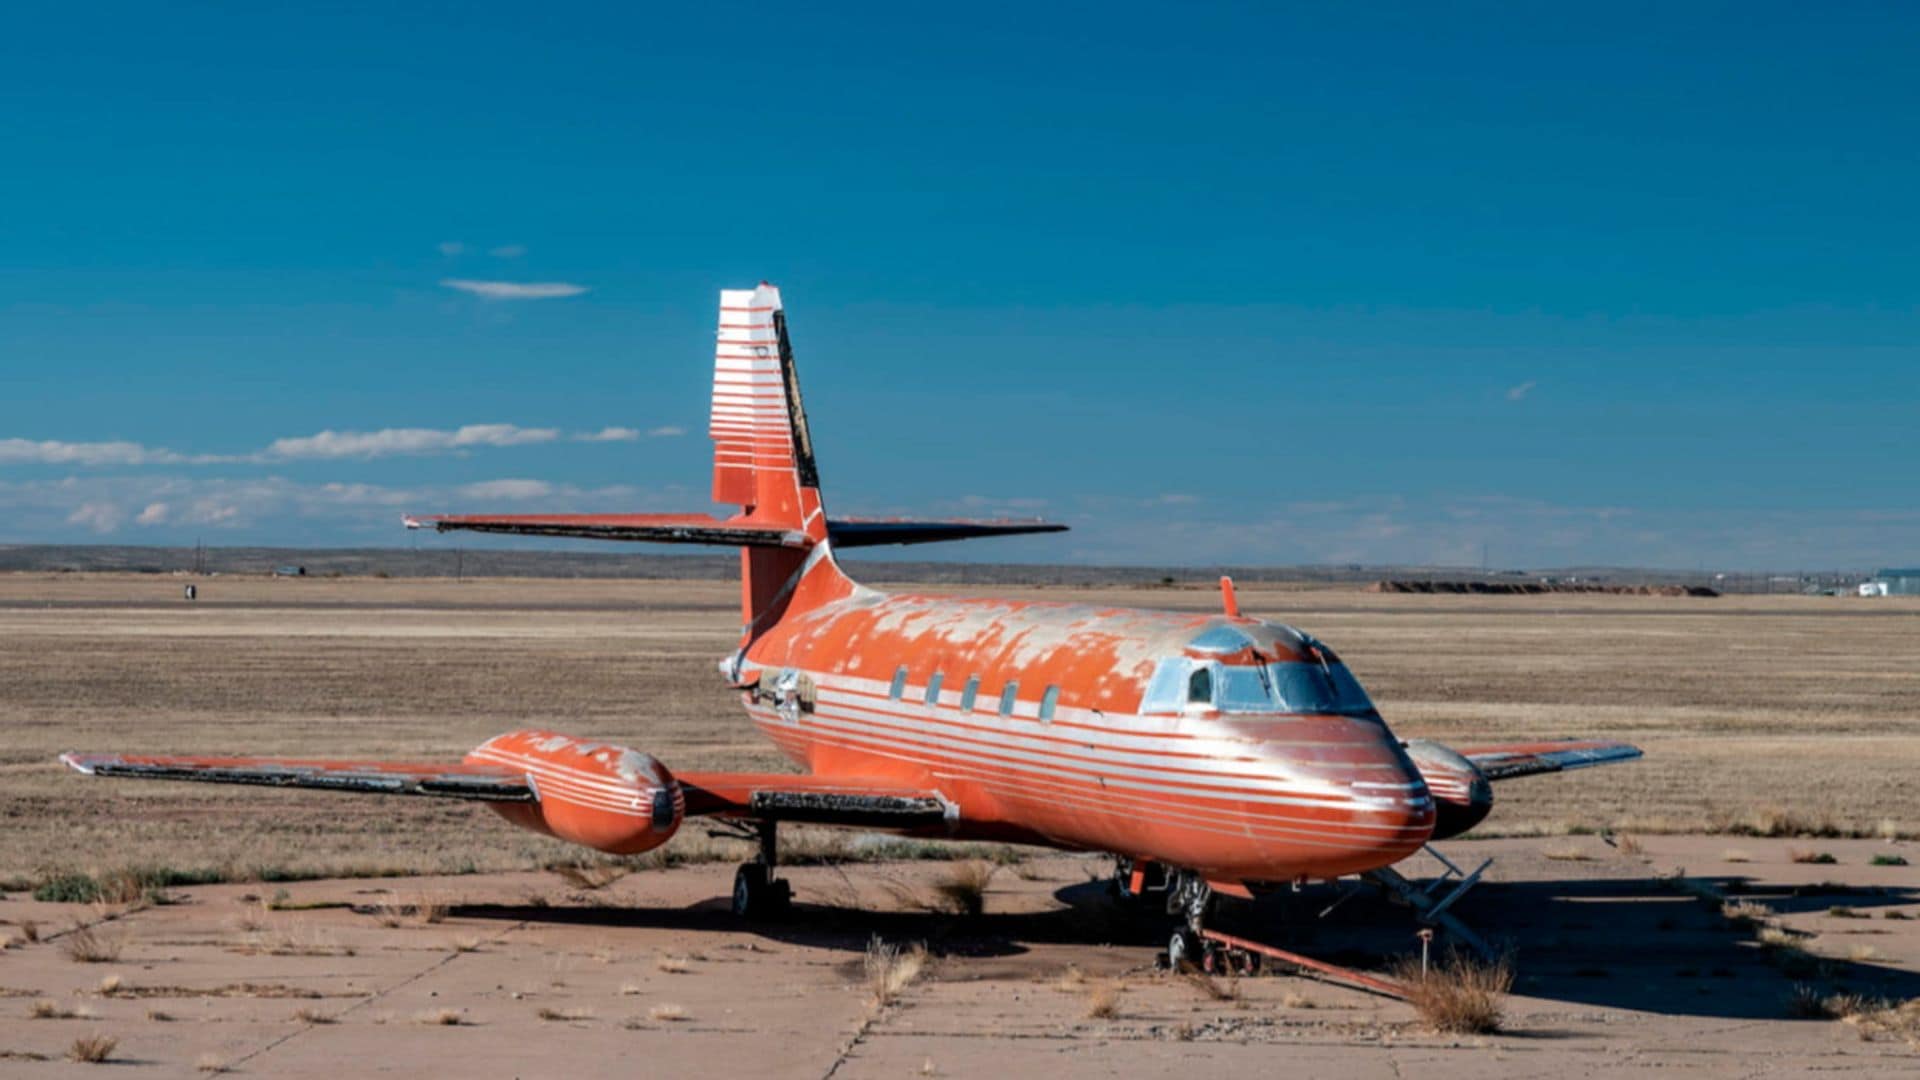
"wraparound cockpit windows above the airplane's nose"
1140,657,1379,717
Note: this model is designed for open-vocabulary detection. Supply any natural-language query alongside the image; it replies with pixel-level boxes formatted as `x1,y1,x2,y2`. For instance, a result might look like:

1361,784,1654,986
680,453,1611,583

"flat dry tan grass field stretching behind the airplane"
0,575,1920,882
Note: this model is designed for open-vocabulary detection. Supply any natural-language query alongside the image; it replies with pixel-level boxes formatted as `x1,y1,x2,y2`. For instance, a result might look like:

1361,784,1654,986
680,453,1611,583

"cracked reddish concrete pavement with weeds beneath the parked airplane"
0,836,1920,1078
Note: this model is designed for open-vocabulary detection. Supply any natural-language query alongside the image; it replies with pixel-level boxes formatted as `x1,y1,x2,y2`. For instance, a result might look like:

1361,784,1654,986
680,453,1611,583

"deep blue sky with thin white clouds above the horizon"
0,4,1920,569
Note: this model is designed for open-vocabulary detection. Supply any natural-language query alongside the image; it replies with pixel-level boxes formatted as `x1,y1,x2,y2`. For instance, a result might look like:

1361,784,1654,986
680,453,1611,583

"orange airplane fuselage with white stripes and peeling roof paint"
728,561,1434,882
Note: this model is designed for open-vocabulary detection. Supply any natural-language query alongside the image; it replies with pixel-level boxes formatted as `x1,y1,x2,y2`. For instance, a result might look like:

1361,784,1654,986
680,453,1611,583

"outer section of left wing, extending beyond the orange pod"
60,753,540,803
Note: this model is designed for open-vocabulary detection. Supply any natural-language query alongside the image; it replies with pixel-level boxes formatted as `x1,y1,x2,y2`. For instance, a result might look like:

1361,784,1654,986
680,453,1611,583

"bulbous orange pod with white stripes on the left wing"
467,730,687,855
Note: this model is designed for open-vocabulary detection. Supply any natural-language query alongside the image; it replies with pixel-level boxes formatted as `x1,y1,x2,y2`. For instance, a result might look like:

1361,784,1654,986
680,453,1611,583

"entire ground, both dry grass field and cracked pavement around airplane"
0,575,1920,1078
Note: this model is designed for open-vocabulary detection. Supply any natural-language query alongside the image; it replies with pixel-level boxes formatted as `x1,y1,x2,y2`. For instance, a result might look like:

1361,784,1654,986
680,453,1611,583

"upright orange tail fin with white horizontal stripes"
708,281,852,634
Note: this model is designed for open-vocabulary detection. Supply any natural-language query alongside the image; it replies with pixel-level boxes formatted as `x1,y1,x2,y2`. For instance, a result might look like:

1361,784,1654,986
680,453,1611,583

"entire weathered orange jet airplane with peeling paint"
61,282,1640,965
